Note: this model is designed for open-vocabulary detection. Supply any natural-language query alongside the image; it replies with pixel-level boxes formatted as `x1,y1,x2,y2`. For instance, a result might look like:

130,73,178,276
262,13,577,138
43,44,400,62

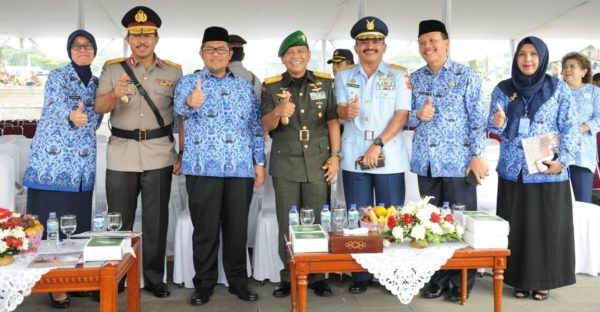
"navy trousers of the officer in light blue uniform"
342,170,406,282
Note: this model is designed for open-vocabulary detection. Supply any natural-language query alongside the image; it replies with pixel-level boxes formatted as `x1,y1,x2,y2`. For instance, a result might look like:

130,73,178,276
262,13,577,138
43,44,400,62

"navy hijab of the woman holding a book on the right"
498,36,558,140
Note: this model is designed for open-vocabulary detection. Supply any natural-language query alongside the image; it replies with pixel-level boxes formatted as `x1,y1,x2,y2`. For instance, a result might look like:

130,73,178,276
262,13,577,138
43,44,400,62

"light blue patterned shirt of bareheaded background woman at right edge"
571,84,600,172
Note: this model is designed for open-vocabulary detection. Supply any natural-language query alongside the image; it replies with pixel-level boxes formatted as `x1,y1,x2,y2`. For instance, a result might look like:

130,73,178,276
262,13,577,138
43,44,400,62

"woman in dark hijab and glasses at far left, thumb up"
23,30,102,308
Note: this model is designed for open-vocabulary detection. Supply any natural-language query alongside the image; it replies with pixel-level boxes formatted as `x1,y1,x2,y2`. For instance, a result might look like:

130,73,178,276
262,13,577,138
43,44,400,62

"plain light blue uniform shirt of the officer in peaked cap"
335,62,410,174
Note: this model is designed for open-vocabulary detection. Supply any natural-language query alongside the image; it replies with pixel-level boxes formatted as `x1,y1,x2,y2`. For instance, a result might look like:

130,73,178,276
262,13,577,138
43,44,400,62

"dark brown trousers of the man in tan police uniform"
106,166,173,286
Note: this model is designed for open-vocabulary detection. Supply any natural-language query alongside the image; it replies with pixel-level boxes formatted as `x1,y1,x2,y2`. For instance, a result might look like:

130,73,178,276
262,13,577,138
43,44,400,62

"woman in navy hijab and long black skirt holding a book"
488,37,579,300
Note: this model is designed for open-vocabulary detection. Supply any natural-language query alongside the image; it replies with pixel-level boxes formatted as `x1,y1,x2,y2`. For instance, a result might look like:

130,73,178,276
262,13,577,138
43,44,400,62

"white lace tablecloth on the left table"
0,239,85,312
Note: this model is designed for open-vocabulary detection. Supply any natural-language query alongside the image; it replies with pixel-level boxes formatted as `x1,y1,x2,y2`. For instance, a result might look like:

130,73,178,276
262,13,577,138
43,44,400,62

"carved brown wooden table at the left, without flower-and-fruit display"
31,237,142,312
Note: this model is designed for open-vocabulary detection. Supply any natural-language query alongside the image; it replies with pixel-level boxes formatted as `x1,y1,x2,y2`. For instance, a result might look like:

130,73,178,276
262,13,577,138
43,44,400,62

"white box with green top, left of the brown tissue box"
290,224,329,253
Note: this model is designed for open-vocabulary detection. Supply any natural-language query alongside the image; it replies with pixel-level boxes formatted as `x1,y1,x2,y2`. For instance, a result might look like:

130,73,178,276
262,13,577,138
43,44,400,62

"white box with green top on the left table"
83,237,131,262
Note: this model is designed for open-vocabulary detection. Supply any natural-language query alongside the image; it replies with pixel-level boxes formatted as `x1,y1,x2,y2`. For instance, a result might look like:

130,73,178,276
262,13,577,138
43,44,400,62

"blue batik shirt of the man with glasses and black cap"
175,68,265,178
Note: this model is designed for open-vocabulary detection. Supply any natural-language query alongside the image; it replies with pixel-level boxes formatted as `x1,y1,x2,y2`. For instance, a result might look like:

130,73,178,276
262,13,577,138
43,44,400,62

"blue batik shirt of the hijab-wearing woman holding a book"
488,81,580,183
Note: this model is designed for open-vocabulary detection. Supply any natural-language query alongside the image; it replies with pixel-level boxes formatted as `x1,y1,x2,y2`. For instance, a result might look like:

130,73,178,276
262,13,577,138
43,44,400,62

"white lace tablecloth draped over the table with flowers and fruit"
352,242,467,304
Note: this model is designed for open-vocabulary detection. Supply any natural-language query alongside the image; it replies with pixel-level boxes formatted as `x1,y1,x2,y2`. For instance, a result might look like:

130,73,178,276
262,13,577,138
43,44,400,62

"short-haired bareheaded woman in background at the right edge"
562,52,600,203
